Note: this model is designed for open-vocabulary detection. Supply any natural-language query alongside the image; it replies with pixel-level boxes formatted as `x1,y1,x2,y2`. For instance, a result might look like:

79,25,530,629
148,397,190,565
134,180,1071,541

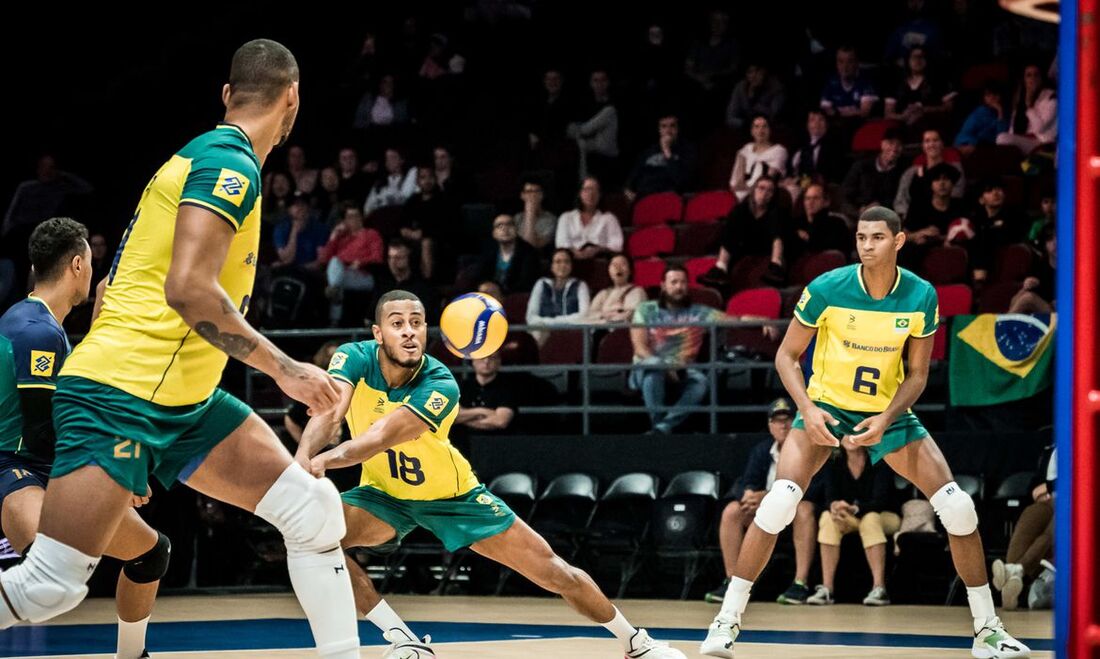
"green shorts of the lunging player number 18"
340,485,516,551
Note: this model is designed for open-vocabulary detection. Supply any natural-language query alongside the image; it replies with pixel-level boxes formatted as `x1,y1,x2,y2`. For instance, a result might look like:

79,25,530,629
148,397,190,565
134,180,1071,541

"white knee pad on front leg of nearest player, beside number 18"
256,462,347,558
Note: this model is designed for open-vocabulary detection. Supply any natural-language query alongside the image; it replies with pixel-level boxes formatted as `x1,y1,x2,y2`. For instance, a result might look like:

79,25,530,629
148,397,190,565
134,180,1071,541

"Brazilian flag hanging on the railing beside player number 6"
947,314,1057,406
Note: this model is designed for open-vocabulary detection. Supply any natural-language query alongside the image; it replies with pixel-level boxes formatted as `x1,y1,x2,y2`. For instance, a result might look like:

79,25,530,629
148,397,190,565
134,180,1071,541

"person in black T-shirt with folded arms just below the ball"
454,352,519,435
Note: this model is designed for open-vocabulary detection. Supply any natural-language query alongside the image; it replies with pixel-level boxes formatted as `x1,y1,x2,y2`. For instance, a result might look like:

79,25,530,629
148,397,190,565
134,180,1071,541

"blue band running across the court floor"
0,618,1054,657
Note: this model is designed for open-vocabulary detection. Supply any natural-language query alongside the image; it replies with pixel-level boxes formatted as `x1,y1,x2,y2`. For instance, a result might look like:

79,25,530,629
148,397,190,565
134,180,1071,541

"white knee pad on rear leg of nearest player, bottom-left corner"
0,534,99,623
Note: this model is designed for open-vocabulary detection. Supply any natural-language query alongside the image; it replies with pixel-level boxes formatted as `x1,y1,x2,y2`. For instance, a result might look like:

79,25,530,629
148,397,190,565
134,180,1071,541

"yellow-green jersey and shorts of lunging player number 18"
329,341,515,551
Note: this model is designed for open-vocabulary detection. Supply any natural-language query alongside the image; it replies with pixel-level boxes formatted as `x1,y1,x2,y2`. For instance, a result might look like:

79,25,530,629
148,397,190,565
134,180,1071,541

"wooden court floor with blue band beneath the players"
10,595,1054,659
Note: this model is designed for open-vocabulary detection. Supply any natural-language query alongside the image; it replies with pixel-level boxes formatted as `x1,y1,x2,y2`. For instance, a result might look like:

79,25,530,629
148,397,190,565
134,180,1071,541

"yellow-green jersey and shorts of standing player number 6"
793,265,939,462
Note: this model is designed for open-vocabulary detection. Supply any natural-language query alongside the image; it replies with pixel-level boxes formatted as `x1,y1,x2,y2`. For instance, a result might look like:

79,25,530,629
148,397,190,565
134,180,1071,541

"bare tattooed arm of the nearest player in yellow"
164,206,338,414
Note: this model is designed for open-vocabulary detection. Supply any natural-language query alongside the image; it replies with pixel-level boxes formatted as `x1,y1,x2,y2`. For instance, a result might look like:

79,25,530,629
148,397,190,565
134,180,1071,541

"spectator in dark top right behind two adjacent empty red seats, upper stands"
625,113,695,201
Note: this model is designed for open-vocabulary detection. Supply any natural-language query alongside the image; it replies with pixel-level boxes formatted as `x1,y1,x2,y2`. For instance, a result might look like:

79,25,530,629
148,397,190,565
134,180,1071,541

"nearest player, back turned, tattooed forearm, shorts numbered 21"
0,40,359,659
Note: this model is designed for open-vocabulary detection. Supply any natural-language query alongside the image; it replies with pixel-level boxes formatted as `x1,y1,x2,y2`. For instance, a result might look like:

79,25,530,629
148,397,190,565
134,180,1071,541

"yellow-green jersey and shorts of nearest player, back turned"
52,123,261,494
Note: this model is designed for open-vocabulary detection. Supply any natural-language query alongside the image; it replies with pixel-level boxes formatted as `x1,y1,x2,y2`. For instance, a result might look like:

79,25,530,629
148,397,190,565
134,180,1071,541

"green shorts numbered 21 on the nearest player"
50,375,252,495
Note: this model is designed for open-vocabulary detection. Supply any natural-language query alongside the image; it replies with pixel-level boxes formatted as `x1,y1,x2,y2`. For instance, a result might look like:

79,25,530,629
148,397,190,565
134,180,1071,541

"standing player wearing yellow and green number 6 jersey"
700,207,1031,659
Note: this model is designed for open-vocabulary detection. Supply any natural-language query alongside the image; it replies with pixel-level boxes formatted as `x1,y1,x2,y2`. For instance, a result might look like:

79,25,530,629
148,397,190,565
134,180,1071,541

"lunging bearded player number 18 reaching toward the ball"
295,290,684,659
